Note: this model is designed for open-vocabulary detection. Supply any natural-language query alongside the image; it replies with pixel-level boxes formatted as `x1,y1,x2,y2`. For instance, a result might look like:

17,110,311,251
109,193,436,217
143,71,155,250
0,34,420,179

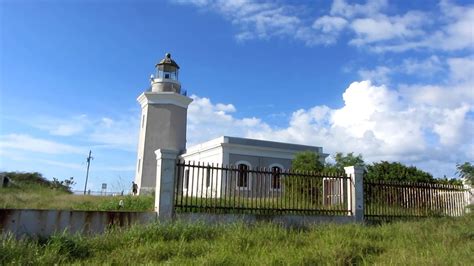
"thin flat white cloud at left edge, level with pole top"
0,134,85,154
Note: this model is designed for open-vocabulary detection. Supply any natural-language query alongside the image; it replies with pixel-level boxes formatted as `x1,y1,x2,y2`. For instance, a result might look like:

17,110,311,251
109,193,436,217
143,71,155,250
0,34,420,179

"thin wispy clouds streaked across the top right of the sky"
170,0,474,53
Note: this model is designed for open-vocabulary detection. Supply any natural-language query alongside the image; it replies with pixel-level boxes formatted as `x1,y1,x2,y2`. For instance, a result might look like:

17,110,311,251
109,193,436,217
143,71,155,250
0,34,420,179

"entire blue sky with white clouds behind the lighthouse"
0,0,474,190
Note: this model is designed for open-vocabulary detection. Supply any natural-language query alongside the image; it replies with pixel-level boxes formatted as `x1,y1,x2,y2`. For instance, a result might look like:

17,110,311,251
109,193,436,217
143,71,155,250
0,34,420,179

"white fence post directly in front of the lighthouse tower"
155,149,179,221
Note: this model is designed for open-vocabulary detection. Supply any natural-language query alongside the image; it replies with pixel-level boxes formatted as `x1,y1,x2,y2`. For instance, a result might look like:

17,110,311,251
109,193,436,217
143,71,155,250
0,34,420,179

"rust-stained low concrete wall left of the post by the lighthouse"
0,209,156,237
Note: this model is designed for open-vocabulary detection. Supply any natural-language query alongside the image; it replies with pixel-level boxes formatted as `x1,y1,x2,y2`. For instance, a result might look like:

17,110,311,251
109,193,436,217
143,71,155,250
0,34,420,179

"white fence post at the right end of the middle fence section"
344,166,364,223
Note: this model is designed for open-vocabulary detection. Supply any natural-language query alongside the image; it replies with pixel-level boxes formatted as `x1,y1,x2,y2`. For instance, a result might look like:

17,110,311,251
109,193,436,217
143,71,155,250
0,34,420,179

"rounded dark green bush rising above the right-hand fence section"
365,161,435,183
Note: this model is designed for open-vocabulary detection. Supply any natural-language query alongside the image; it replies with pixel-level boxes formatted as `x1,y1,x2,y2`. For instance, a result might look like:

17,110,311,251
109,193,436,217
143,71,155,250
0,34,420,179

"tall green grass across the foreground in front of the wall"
0,214,474,265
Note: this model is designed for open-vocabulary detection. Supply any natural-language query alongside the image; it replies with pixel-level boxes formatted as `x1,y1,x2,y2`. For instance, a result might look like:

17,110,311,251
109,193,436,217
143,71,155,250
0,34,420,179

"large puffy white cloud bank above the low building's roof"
183,81,474,174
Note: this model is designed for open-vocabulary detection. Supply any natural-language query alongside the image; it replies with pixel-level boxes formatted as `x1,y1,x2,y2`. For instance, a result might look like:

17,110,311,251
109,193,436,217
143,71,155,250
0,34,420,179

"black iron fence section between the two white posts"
174,161,351,215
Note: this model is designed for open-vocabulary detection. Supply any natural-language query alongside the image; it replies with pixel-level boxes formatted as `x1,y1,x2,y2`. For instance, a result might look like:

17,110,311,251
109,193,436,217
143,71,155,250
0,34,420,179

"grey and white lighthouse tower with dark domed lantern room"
135,53,192,194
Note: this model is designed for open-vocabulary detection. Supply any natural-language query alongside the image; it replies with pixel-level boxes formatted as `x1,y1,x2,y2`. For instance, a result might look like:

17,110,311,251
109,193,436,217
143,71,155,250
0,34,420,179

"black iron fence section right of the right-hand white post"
364,180,467,221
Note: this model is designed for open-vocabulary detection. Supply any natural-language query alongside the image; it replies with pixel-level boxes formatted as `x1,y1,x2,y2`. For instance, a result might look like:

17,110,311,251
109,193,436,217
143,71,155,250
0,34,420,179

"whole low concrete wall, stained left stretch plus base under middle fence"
0,209,354,237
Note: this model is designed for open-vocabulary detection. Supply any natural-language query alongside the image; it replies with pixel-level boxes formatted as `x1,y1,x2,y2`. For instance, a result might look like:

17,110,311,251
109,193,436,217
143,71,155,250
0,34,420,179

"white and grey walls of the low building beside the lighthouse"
177,136,327,200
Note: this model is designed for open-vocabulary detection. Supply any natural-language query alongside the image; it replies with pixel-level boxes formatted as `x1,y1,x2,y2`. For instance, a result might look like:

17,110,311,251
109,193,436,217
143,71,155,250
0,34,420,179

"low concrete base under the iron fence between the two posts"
175,213,355,228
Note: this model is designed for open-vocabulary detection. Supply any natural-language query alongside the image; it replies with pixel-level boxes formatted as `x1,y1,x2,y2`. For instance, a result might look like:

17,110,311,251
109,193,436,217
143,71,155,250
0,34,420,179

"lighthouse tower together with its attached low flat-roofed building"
135,54,328,194
